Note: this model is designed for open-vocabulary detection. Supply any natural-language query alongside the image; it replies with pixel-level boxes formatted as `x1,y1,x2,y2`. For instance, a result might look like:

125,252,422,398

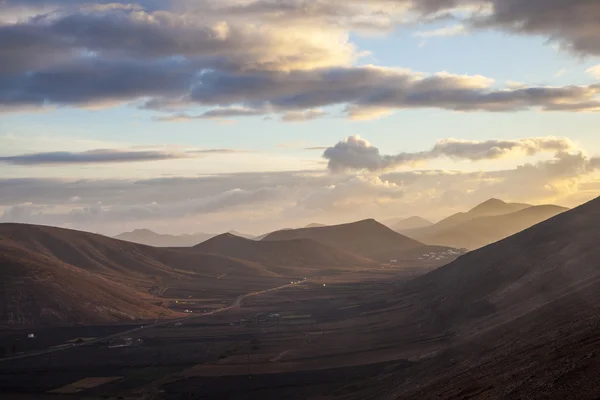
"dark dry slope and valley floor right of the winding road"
0,199,600,400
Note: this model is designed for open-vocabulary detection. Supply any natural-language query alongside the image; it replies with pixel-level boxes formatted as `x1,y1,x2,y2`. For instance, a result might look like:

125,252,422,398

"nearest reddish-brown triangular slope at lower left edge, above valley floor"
0,242,177,326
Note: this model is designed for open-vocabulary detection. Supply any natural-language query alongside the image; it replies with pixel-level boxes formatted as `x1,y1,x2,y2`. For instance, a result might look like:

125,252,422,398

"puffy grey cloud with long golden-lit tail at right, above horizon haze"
323,135,577,172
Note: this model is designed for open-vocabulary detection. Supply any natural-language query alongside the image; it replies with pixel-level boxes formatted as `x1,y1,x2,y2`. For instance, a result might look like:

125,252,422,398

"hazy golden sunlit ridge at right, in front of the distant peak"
418,205,568,249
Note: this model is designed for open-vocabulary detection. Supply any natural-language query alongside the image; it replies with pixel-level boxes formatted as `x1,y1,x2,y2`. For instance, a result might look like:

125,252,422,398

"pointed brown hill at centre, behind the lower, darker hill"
262,219,446,262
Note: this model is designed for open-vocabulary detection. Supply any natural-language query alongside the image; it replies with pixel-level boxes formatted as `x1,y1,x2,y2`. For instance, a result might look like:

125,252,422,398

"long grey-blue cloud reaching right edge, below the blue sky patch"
190,67,600,116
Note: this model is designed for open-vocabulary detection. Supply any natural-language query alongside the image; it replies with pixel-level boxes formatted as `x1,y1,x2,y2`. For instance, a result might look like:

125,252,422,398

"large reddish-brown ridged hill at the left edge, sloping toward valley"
0,224,279,325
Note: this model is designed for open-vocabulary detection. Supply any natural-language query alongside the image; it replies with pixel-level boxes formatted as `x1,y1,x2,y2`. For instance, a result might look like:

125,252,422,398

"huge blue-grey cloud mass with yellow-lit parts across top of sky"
0,0,600,121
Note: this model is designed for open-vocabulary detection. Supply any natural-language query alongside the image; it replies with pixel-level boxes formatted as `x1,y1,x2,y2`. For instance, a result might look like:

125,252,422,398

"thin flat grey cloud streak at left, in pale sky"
0,149,240,165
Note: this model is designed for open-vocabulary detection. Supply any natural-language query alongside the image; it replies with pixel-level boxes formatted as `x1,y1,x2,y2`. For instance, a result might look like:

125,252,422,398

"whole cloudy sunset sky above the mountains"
0,0,600,235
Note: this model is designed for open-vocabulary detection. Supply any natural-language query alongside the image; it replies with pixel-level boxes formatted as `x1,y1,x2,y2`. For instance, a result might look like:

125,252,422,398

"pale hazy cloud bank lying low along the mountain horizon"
0,143,600,234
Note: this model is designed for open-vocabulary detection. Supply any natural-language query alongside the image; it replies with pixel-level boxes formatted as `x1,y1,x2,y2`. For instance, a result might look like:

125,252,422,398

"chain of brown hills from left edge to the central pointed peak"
0,220,459,325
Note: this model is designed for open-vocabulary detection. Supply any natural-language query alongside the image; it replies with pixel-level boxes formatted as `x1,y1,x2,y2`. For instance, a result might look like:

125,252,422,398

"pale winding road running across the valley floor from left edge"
0,280,300,362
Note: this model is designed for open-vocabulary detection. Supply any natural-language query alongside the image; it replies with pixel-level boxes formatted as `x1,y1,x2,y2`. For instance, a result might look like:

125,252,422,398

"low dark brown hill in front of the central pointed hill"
194,233,374,267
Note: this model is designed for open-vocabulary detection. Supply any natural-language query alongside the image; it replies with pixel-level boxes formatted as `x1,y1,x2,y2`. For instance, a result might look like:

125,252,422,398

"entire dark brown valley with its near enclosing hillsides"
0,200,600,400
